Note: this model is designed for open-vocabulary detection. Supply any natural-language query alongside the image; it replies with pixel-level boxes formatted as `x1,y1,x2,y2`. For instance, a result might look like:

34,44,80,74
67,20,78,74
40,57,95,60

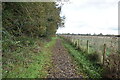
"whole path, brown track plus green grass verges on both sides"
2,37,100,79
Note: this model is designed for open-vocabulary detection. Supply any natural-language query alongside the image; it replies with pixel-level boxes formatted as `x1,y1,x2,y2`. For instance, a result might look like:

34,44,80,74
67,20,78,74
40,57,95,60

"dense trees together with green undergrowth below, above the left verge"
2,2,62,52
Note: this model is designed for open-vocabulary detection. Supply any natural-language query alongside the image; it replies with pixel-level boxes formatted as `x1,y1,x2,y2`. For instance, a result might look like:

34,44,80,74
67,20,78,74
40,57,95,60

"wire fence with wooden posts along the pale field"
61,35,118,64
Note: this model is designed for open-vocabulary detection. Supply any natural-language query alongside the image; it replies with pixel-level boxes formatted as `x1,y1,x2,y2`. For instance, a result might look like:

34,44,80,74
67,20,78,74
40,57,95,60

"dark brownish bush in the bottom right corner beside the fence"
103,54,120,79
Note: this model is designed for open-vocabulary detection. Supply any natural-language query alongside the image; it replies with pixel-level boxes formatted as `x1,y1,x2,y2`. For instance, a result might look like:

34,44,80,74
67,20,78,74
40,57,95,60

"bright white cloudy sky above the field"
57,0,119,34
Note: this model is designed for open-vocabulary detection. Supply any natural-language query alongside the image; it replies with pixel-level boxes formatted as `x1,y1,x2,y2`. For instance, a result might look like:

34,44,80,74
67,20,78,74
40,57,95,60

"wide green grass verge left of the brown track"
2,38,56,78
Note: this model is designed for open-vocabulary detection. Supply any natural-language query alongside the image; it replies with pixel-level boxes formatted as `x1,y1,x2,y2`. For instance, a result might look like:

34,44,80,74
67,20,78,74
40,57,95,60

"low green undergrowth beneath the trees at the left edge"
2,28,34,53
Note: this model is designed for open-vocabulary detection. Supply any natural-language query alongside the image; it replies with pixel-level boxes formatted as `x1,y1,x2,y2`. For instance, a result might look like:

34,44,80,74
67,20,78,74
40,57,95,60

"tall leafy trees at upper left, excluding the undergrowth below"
2,2,64,37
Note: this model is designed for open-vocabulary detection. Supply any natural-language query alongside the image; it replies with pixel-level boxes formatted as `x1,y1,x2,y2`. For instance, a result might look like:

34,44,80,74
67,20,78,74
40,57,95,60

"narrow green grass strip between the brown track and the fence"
63,38,102,78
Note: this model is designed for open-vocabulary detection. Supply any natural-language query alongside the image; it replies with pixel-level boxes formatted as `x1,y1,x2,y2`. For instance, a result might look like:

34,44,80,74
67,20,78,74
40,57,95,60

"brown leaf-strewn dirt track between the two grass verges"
48,39,82,78
